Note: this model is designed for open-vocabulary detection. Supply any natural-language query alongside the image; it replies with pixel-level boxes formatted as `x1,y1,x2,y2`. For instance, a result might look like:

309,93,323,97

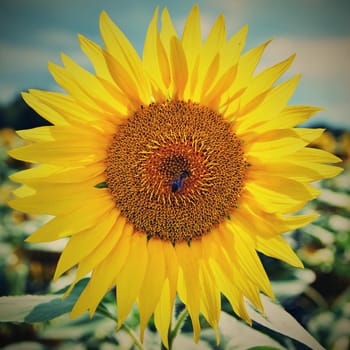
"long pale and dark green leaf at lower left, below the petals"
0,279,88,323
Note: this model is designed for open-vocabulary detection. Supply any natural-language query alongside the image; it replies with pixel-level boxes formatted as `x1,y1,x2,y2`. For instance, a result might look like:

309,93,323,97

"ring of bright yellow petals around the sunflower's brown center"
10,6,341,347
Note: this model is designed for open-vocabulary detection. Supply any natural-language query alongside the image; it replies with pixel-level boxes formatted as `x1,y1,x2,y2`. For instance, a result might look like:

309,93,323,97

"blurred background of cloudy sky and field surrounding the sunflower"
0,0,350,350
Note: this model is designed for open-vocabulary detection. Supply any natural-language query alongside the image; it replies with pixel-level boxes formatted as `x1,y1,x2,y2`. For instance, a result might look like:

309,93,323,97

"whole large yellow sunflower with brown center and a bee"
10,6,341,347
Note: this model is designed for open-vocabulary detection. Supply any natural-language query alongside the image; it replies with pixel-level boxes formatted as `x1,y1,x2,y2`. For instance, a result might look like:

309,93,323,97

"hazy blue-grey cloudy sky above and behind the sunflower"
0,0,350,129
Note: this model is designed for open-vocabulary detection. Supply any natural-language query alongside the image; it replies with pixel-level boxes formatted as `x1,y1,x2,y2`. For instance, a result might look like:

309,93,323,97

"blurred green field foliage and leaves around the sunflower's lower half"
0,119,350,350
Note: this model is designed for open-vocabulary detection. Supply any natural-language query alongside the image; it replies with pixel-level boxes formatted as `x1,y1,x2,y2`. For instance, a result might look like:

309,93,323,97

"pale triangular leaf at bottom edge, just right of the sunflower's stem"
217,312,285,350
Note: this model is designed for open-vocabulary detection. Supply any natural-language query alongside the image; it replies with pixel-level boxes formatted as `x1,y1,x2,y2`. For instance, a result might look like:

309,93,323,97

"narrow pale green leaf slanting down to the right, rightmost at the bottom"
246,295,325,350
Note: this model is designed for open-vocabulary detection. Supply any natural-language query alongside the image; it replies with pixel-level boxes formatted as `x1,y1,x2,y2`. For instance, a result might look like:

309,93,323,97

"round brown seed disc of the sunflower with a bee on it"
105,101,247,244
